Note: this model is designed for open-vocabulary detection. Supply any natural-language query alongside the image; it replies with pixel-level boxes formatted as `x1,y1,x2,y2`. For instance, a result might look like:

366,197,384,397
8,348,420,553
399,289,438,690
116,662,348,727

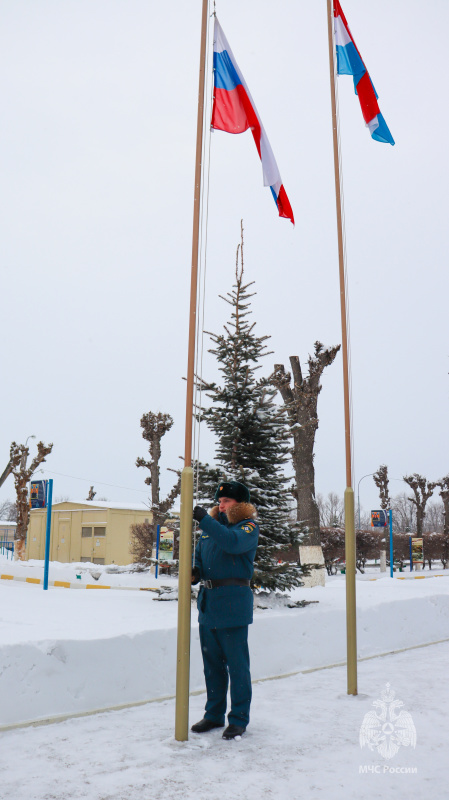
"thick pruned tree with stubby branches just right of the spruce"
269,342,340,545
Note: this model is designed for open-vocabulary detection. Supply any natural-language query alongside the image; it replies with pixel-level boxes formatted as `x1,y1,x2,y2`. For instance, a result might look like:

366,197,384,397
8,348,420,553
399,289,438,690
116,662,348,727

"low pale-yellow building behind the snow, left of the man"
25,500,152,565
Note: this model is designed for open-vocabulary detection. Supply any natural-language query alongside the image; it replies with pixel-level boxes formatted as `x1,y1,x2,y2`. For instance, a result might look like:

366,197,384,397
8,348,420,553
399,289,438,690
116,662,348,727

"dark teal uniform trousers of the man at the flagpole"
199,625,252,728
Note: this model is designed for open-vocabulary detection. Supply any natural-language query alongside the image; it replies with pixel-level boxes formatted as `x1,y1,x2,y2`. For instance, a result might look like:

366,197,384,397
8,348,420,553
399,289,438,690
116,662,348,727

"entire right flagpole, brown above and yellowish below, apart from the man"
327,0,357,695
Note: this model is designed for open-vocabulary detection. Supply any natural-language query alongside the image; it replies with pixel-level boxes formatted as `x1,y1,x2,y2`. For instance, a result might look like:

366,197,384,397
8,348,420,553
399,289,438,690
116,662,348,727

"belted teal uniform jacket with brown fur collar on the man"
194,503,259,628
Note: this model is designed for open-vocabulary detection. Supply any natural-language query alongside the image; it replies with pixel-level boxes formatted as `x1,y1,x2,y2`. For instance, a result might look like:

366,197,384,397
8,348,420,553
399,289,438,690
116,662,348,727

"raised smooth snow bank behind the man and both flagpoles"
0,577,449,725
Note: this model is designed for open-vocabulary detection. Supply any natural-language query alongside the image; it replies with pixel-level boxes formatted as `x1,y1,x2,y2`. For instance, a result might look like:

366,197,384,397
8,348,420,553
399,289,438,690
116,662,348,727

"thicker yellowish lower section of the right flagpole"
345,488,357,694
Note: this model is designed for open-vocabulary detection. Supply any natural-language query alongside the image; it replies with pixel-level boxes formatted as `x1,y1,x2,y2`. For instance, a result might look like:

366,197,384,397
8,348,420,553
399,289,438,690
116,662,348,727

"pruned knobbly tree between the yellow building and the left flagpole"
131,411,181,561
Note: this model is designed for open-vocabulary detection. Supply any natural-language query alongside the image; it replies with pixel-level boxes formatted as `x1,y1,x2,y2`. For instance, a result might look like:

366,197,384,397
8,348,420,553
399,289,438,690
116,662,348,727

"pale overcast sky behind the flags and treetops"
0,0,449,509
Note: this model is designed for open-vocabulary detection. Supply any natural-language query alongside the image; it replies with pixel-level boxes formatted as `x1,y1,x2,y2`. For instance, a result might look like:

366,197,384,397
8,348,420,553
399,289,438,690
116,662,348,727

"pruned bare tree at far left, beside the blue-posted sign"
11,442,53,560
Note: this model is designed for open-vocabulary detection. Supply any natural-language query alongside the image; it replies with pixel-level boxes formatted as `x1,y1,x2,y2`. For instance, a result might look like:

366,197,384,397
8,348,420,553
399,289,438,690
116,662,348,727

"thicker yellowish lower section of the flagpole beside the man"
175,467,193,742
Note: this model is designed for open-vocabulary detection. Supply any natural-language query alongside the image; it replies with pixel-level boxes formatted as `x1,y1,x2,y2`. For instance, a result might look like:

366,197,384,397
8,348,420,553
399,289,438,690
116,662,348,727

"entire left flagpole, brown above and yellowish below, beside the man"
175,0,208,742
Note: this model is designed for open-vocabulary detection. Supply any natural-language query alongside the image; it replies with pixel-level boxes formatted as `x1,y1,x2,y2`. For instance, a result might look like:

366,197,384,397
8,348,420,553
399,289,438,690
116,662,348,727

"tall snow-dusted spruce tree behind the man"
202,223,301,590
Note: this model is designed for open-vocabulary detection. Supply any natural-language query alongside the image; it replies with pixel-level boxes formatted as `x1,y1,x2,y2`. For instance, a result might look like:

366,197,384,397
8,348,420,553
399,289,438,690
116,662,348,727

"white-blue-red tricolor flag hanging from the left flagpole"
211,17,295,224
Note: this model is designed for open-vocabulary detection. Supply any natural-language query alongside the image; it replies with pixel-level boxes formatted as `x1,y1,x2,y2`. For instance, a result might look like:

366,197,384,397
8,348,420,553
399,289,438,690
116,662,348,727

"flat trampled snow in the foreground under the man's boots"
0,632,449,800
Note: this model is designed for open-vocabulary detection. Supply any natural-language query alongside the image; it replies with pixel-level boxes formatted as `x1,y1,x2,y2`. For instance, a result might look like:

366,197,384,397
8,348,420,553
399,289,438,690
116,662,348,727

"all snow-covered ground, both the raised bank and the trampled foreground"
0,558,449,800
